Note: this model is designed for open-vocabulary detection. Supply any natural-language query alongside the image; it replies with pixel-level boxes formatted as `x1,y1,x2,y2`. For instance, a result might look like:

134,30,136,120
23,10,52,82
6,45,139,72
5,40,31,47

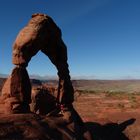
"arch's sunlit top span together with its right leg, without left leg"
13,14,74,104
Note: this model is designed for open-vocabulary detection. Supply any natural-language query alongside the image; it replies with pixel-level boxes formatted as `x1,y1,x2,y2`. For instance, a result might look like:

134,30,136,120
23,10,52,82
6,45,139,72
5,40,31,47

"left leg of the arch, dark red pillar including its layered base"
10,67,31,113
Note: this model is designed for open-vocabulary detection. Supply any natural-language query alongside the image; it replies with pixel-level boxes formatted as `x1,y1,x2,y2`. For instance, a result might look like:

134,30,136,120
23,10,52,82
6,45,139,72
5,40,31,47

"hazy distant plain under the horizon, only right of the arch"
73,80,140,93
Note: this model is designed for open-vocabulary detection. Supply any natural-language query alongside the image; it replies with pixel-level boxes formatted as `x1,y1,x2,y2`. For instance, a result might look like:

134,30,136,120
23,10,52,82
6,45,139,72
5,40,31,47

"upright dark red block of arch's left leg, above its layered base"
11,67,31,104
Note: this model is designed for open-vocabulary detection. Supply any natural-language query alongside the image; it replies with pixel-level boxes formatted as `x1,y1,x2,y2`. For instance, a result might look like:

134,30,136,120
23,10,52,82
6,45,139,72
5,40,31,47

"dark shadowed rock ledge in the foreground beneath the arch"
0,114,92,140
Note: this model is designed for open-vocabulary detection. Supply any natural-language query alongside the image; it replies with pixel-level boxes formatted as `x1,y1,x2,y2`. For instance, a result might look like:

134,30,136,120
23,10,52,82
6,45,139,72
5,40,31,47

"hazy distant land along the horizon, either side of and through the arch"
0,74,140,93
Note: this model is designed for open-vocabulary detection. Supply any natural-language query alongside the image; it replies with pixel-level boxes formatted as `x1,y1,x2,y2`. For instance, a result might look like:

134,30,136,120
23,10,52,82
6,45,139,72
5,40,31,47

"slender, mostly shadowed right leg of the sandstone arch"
42,39,74,105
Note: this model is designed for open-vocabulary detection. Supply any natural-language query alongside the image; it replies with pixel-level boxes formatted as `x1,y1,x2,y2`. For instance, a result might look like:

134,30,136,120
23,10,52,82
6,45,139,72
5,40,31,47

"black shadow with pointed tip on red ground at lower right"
86,118,136,140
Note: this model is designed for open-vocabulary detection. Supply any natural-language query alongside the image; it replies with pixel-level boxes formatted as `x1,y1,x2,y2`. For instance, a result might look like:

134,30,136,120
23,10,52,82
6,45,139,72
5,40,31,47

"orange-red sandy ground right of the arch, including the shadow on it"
74,93,140,140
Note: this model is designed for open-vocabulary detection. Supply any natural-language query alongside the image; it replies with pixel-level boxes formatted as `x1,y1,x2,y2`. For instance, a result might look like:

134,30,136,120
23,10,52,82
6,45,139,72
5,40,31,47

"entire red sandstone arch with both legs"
3,14,74,112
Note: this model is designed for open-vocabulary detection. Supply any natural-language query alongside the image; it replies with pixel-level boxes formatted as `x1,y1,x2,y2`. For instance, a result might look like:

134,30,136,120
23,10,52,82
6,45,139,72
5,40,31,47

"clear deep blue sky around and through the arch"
0,0,140,79
